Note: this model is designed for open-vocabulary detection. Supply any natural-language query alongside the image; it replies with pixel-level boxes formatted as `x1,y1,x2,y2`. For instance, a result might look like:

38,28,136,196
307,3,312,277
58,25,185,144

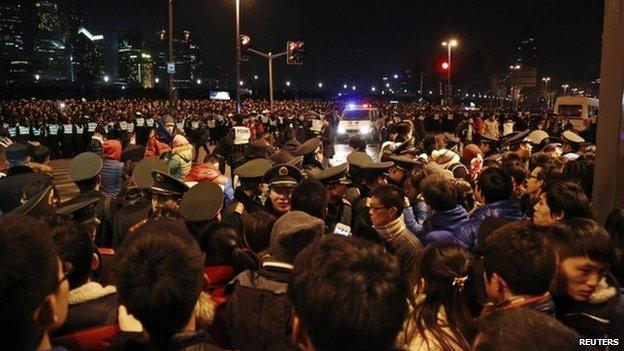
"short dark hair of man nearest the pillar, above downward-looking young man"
542,181,592,218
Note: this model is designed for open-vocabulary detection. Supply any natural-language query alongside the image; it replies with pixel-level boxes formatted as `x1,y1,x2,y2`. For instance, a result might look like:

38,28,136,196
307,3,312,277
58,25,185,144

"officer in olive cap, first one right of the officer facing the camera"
314,163,352,228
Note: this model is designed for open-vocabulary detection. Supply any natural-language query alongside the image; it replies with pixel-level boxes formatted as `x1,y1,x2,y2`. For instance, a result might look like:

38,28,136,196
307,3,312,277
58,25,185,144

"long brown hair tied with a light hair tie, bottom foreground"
406,243,474,351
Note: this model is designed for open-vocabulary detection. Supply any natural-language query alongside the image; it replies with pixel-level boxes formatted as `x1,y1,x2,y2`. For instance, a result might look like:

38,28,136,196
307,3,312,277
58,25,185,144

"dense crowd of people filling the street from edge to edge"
0,100,624,351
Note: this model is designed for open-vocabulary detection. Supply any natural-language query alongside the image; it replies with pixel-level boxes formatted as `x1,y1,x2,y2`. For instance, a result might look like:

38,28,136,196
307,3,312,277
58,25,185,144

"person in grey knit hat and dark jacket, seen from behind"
224,211,325,350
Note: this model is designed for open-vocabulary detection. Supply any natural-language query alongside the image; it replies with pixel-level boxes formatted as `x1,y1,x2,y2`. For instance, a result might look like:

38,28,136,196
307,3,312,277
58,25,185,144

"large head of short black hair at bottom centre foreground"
288,235,409,351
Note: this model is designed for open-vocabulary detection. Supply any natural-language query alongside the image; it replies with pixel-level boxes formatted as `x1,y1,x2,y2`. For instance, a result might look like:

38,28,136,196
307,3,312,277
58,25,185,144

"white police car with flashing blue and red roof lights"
336,103,381,141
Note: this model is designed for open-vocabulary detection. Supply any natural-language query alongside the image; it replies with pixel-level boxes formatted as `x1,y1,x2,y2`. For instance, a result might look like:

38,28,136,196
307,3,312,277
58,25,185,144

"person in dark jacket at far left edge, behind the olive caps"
0,144,54,213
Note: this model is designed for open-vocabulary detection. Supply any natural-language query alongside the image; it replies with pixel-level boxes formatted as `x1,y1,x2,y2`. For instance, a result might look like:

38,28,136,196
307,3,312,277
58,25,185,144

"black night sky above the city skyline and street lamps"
80,0,604,89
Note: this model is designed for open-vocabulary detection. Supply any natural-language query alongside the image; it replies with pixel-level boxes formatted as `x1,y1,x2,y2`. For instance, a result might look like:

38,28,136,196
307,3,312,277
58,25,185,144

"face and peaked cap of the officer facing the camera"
263,164,303,218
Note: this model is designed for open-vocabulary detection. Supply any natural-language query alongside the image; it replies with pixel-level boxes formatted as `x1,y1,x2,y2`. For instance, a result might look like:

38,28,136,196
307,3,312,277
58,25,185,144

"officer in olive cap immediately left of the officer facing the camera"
223,158,273,233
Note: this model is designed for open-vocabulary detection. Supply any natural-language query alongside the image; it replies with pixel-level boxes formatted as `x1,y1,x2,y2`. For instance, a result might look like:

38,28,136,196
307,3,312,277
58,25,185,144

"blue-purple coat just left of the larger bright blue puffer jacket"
420,205,468,247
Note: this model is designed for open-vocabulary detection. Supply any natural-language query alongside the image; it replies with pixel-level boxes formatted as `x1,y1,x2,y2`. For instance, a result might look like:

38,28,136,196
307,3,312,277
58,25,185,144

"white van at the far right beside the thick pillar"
554,96,598,132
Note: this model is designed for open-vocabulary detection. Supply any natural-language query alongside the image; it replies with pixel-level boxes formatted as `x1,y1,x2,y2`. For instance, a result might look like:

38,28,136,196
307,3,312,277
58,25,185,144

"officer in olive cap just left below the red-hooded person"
59,152,112,247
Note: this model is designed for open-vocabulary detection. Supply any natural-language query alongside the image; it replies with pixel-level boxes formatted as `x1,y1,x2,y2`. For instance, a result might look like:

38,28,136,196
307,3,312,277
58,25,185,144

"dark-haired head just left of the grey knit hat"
198,222,258,272
